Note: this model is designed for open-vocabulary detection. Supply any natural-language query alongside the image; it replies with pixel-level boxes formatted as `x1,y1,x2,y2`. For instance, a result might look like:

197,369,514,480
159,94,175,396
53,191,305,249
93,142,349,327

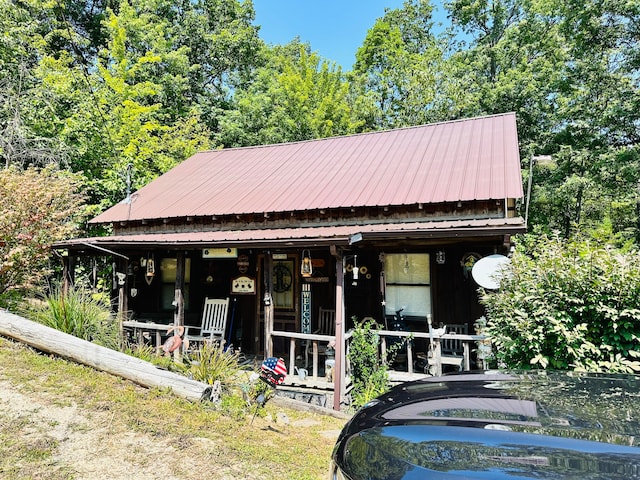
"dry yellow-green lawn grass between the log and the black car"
0,338,345,480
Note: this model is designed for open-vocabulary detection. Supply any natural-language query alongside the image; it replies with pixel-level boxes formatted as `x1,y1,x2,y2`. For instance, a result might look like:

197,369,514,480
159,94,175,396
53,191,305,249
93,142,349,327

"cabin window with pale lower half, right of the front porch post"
384,253,431,318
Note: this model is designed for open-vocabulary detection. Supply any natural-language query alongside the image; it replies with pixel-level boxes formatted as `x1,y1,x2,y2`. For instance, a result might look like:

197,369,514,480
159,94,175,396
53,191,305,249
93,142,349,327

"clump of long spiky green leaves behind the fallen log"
19,286,120,349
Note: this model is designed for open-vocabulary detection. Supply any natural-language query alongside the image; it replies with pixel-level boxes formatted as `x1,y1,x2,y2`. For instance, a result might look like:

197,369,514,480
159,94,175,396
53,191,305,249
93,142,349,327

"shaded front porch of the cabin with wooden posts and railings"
58,223,504,409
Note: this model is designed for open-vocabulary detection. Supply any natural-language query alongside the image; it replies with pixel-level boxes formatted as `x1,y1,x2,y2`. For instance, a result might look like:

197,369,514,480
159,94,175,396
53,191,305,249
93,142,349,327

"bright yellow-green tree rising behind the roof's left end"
37,2,209,207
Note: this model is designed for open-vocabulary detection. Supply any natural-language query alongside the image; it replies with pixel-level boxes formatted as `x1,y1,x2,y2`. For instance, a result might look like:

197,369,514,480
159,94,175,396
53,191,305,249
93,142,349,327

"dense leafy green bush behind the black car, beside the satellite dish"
481,232,640,372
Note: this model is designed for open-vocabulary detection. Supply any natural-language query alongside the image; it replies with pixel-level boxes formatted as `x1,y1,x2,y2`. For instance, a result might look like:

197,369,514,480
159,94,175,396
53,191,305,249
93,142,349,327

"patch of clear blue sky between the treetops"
253,0,403,71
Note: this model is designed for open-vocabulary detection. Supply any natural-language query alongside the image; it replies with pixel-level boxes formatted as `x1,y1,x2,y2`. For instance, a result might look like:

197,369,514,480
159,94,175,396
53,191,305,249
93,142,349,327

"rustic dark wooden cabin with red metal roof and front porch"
56,113,526,409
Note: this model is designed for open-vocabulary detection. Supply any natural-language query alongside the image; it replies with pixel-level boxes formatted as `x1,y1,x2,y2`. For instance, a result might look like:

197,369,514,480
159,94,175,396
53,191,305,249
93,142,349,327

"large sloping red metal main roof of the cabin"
92,113,523,223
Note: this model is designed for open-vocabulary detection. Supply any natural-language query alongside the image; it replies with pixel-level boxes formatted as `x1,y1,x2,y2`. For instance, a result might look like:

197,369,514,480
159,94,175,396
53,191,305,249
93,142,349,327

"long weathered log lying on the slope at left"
0,310,211,401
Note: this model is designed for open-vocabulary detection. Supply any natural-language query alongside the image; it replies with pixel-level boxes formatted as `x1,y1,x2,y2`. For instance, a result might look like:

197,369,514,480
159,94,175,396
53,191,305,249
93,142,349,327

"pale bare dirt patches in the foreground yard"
0,370,339,480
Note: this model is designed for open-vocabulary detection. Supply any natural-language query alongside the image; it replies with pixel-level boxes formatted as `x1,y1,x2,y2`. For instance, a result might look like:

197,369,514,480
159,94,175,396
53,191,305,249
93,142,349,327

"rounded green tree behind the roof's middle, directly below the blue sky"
216,40,356,146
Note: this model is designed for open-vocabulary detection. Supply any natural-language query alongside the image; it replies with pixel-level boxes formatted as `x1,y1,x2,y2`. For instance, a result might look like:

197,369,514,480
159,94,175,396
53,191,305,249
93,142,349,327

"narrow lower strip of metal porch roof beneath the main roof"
54,217,526,249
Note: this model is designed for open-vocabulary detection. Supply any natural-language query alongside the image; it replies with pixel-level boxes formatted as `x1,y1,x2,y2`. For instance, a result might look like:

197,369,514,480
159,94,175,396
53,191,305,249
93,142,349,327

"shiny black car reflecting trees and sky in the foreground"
330,371,640,480
